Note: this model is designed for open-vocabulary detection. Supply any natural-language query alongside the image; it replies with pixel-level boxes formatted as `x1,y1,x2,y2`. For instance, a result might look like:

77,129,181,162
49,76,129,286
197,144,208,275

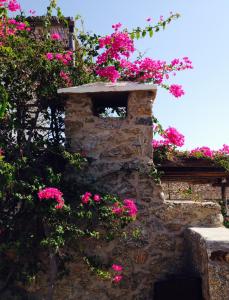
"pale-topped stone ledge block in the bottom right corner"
186,227,229,300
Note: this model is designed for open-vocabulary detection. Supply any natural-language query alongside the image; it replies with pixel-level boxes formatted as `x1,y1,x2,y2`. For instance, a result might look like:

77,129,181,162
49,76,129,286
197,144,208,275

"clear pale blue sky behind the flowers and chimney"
20,0,229,149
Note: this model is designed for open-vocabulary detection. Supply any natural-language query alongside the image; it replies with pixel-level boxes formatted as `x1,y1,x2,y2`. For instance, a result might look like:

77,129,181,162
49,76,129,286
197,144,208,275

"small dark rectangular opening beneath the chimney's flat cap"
90,92,129,119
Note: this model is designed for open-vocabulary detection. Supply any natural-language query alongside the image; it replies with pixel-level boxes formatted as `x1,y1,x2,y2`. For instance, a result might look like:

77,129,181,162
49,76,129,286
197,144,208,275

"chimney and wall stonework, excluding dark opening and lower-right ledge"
32,82,222,300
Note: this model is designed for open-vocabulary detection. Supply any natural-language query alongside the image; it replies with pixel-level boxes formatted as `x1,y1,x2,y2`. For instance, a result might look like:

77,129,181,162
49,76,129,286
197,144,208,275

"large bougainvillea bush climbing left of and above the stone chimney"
0,0,192,299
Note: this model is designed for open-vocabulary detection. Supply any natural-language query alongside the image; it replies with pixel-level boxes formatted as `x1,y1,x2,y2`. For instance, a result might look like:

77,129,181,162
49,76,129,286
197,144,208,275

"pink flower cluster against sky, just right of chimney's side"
152,127,185,148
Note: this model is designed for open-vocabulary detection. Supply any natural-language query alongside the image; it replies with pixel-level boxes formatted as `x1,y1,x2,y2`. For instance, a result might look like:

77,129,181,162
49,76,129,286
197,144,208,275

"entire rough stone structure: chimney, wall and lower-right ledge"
49,82,229,300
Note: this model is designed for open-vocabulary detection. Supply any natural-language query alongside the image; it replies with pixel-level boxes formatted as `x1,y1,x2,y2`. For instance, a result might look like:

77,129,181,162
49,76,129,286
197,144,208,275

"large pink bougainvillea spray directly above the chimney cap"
96,24,193,98
